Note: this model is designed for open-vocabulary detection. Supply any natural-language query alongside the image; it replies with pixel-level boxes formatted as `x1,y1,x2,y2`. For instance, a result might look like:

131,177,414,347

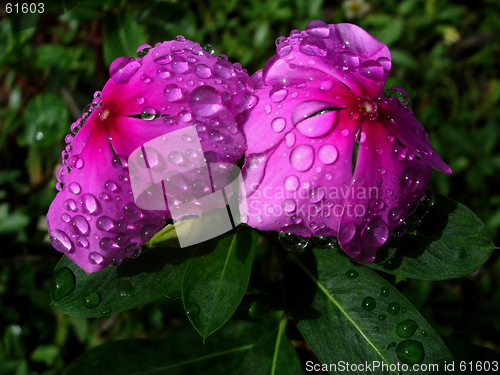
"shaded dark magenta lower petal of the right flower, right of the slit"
338,119,431,263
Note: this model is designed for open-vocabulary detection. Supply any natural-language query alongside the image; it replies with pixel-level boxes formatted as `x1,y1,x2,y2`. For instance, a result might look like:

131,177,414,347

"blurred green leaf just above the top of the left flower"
104,10,147,66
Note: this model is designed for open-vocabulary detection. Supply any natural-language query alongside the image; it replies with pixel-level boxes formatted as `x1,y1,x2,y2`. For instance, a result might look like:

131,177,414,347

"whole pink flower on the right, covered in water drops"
243,21,451,263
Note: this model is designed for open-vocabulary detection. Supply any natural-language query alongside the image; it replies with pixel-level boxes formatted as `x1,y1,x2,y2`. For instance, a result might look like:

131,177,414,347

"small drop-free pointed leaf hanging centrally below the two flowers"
182,225,258,338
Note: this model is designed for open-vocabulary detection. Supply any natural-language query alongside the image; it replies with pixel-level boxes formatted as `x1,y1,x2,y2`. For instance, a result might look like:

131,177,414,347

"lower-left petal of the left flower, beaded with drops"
47,127,166,272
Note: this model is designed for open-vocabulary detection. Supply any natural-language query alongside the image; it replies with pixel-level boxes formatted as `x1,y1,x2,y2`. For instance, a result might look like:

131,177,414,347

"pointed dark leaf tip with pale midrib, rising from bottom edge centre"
238,317,303,375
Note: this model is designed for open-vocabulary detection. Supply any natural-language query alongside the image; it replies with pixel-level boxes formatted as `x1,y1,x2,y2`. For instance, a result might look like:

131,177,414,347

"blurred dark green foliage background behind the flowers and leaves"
0,0,500,375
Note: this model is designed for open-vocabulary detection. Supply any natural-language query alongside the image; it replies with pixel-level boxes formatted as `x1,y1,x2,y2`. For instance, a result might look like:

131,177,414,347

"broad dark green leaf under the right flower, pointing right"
369,194,495,280
